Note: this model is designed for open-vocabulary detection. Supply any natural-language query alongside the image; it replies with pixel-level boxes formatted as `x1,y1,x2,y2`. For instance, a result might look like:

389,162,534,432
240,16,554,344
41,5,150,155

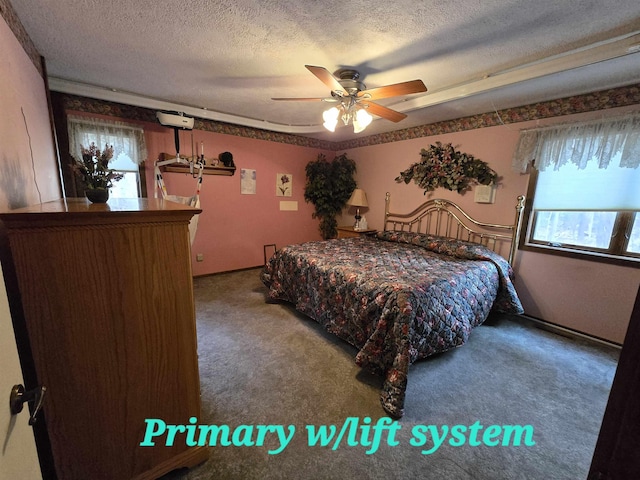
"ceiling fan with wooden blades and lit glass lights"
272,65,427,133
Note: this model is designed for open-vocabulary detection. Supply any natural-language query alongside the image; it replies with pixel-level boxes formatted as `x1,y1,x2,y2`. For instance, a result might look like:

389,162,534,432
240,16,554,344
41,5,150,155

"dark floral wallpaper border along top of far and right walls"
55,82,640,151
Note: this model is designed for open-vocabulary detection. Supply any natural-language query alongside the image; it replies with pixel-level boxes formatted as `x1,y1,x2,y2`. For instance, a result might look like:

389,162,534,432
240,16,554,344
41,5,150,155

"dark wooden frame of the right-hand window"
518,168,640,268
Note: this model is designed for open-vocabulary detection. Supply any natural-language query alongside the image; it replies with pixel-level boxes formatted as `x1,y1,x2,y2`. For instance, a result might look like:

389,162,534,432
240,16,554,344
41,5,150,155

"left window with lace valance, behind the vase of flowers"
68,115,147,198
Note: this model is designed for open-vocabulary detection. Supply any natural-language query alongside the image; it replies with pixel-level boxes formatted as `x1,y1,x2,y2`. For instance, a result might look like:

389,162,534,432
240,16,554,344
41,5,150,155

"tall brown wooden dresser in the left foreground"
0,199,208,480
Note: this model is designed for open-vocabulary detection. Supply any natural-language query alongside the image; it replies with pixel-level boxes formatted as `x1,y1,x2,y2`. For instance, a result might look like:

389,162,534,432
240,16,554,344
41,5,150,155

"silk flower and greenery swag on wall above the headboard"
395,142,498,195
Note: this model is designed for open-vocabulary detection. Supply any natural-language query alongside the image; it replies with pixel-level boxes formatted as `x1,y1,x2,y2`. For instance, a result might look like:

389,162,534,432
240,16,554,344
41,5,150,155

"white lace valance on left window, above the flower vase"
67,115,147,164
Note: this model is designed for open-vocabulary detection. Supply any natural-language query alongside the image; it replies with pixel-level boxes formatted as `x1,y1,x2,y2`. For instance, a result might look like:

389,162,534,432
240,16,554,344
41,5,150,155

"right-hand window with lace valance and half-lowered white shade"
514,116,640,261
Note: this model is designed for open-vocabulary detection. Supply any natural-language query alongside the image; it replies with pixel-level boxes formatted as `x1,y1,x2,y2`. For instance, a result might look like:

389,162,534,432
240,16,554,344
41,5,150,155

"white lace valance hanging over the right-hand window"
512,113,640,173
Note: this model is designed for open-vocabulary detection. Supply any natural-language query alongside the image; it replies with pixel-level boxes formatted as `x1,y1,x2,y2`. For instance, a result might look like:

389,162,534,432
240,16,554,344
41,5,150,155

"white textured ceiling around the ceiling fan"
10,0,640,141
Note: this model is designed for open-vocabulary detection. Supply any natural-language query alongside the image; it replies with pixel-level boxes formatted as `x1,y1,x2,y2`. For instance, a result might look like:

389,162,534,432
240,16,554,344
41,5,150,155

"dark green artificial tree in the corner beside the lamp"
304,153,356,240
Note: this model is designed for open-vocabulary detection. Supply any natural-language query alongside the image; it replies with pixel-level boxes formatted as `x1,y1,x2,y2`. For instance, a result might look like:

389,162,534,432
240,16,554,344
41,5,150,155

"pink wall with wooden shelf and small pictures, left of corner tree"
145,124,333,275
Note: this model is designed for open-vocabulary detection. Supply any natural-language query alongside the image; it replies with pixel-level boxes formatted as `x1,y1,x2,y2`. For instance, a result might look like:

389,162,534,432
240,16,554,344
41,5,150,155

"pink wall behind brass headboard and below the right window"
341,109,640,343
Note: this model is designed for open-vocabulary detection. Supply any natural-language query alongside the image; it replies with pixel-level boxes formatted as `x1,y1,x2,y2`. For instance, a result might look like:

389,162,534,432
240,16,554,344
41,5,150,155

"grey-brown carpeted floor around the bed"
163,269,619,480
